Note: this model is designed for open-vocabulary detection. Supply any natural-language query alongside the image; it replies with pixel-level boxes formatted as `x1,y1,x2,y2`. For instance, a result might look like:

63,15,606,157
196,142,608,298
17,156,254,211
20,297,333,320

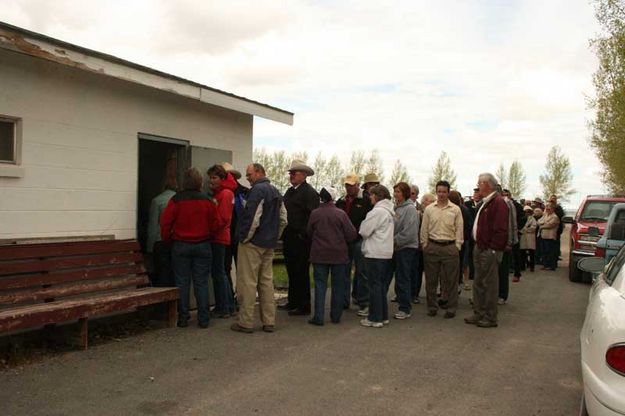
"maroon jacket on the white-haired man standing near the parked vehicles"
475,195,509,251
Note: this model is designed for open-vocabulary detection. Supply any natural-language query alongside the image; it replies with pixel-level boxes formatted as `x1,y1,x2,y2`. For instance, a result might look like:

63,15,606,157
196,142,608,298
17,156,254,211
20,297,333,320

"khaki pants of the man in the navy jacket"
237,243,276,328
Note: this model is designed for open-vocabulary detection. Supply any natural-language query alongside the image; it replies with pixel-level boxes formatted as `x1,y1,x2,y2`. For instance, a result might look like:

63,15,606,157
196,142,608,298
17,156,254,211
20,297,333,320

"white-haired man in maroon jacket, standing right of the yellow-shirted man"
464,173,509,328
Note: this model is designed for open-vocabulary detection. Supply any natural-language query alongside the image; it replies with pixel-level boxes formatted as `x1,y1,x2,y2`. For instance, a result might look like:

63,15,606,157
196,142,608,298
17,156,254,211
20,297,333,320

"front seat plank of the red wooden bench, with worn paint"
0,288,178,332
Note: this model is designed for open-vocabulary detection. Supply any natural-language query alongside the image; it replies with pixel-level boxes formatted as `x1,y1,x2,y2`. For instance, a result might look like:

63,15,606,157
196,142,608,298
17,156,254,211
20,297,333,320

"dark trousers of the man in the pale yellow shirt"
423,242,460,313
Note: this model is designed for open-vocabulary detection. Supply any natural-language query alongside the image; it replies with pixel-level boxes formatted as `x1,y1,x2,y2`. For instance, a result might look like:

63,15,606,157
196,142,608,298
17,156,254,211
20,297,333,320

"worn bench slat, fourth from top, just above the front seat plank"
0,275,148,306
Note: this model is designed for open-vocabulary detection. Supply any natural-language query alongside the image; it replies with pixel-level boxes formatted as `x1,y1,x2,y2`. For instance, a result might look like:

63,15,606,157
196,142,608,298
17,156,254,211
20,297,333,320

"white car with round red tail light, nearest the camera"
578,246,625,416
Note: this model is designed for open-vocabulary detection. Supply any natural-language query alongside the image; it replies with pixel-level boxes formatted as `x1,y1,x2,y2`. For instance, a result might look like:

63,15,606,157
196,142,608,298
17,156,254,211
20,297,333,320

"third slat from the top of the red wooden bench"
0,264,145,293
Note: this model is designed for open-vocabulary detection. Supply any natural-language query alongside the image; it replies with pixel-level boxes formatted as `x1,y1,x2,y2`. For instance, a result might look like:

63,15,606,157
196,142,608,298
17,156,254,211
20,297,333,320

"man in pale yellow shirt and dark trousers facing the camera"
421,181,464,319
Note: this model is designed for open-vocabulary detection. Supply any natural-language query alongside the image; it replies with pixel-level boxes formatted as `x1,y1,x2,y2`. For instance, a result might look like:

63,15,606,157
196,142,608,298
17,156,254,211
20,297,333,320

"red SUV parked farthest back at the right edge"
562,195,625,282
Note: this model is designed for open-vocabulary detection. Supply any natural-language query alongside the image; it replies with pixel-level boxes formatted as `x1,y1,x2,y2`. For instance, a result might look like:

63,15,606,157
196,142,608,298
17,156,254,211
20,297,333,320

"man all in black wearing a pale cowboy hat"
279,160,319,315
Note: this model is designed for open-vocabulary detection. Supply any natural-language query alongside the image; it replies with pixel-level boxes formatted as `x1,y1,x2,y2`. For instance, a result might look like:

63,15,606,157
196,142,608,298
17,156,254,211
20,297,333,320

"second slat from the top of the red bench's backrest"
0,253,143,275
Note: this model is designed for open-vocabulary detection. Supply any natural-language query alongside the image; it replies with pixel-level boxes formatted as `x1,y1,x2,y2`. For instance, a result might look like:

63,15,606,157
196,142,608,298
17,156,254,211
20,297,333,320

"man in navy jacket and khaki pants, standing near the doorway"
230,163,286,333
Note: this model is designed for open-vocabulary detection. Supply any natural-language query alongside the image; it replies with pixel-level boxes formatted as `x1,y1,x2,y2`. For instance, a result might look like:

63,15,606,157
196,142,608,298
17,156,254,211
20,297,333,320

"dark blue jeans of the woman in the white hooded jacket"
365,257,391,322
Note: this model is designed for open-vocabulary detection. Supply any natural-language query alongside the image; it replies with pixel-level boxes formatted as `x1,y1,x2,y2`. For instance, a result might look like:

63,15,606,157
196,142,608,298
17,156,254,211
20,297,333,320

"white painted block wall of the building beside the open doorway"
0,50,253,239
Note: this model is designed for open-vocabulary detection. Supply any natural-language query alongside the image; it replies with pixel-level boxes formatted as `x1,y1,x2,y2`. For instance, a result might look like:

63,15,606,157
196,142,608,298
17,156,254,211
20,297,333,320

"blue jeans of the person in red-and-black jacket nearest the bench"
172,241,212,324
